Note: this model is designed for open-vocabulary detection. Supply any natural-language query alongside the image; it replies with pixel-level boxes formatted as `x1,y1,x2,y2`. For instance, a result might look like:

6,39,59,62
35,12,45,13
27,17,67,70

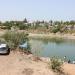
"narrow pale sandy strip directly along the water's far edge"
29,33,75,40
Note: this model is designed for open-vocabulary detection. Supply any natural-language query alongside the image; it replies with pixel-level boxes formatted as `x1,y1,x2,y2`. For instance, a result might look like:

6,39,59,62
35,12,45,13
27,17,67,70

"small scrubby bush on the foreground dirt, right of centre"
50,57,63,72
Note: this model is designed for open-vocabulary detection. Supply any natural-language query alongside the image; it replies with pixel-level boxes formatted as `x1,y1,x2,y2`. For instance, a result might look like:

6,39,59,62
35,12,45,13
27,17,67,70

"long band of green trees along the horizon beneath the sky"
0,18,75,33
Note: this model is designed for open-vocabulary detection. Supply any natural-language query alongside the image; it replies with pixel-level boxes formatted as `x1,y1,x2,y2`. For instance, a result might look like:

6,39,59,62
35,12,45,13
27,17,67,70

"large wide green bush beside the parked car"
2,31,28,49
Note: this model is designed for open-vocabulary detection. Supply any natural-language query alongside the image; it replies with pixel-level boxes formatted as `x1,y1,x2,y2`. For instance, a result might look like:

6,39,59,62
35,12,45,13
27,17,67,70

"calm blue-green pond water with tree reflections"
30,39,75,60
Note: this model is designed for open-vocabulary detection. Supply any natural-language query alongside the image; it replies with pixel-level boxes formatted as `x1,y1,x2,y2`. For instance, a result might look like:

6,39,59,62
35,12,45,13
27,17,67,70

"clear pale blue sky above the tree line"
0,0,75,21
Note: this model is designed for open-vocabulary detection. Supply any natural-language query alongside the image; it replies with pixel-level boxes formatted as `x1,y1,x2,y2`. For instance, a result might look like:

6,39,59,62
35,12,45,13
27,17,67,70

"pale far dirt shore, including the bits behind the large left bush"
0,30,75,40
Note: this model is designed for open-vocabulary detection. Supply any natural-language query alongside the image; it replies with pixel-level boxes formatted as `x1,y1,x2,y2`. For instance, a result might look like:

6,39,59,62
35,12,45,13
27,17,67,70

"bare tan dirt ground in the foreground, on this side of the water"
0,52,75,75
